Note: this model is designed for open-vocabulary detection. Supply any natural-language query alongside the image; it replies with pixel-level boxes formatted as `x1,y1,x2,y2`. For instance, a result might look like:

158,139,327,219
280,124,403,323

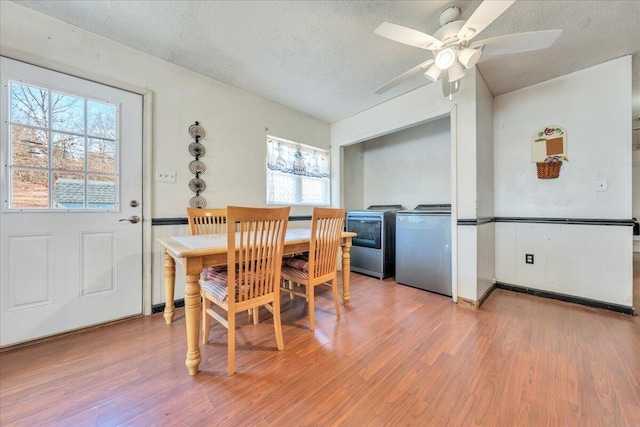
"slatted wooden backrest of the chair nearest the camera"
227,206,290,304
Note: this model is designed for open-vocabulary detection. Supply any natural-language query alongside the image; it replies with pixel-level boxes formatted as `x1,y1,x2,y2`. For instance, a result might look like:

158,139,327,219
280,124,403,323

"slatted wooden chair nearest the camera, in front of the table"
201,206,290,376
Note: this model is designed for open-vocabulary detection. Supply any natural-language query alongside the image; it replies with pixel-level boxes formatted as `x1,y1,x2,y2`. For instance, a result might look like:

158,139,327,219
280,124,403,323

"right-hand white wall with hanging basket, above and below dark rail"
493,56,633,307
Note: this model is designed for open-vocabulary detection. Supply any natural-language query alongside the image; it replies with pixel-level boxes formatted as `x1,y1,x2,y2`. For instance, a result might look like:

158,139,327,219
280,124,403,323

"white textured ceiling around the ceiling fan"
11,0,640,123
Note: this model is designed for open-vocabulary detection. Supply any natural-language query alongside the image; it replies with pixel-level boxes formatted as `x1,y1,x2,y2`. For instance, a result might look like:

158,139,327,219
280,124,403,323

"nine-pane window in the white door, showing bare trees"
7,81,118,210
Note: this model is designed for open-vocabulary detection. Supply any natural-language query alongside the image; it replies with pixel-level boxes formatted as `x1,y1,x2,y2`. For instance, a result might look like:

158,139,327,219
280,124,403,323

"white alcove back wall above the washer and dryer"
361,117,451,209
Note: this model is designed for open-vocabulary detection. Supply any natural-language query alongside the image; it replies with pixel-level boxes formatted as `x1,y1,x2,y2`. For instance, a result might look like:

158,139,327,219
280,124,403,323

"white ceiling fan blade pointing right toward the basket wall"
470,30,562,61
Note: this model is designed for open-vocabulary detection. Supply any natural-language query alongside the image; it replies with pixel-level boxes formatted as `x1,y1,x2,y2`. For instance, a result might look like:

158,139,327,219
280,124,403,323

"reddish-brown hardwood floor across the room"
0,268,640,426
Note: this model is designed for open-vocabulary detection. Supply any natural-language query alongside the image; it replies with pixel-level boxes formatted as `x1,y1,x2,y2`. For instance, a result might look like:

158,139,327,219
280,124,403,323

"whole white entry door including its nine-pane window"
0,58,142,346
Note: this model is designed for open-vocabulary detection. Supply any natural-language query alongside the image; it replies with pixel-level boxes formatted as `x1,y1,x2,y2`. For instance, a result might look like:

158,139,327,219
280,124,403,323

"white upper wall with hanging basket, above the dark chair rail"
493,56,631,219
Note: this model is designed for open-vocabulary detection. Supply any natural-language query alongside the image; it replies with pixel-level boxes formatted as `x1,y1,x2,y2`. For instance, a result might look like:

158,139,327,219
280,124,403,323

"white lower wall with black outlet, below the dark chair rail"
496,222,633,307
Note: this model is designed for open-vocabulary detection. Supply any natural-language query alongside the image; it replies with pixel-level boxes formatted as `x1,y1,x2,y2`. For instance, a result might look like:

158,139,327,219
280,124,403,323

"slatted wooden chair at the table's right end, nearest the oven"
281,208,346,331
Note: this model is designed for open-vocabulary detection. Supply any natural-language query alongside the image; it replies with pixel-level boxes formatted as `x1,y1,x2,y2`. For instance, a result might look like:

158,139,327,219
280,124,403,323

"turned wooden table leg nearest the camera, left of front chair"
184,274,202,375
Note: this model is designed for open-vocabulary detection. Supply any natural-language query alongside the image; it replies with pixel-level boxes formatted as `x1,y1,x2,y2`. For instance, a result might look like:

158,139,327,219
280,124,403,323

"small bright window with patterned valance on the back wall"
267,135,330,206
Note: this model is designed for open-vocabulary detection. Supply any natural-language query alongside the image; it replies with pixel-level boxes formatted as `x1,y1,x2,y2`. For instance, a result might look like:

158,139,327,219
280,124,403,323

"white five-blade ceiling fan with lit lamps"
374,0,562,99
